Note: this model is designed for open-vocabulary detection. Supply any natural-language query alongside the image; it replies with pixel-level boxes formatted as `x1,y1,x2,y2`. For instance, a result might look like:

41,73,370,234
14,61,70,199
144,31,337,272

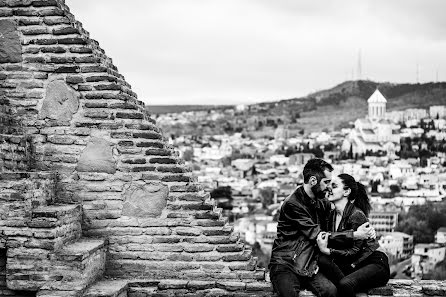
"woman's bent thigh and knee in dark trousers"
338,263,390,297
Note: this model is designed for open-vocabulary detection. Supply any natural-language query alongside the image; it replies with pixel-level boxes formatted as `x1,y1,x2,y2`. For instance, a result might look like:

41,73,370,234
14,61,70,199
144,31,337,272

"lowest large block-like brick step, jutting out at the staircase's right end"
37,238,107,297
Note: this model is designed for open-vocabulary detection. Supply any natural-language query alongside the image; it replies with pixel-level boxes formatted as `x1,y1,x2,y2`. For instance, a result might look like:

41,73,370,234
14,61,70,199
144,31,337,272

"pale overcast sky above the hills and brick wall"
65,0,446,105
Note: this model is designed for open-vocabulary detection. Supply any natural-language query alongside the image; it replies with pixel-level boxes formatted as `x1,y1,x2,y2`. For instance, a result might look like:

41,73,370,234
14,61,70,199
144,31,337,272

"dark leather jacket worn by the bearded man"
269,186,353,277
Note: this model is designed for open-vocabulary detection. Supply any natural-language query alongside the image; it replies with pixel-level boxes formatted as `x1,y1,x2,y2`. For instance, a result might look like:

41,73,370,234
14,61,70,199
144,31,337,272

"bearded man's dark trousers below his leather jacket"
270,265,337,297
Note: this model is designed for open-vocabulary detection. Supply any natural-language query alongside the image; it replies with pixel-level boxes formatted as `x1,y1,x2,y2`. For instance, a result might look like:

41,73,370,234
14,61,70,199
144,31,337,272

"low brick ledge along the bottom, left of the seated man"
123,279,274,297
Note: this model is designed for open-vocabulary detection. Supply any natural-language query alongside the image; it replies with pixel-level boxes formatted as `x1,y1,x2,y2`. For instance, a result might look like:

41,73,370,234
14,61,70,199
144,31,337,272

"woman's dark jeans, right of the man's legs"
337,251,390,297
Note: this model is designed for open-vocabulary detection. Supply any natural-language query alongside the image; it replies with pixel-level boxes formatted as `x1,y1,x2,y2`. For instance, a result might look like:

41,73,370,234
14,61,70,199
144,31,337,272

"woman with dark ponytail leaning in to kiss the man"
317,174,390,297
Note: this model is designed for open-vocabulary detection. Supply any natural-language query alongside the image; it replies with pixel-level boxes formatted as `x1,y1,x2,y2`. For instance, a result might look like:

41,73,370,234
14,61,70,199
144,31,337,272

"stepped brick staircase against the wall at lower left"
0,172,107,297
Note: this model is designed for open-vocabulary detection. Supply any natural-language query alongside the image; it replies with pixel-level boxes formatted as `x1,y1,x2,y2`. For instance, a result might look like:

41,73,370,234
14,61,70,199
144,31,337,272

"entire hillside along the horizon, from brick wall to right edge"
156,80,446,137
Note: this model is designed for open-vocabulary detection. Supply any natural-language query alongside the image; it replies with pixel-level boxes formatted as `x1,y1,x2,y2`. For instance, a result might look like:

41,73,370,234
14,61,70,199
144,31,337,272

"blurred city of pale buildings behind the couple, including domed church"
157,89,446,279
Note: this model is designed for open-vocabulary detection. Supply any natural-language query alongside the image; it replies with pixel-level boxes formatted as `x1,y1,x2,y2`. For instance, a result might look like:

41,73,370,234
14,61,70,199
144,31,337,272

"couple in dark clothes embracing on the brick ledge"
269,159,390,297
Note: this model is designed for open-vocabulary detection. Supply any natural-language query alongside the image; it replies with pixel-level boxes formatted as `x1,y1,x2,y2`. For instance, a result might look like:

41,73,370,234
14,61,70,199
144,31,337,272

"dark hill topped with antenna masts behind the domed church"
256,80,446,132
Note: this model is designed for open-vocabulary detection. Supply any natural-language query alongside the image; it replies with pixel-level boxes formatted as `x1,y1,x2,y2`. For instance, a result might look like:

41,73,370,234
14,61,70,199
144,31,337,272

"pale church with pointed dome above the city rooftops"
342,89,400,157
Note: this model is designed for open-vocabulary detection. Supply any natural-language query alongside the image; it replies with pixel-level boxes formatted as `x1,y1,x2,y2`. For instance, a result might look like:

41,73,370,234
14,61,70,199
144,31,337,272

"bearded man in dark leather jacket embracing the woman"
269,158,374,297
